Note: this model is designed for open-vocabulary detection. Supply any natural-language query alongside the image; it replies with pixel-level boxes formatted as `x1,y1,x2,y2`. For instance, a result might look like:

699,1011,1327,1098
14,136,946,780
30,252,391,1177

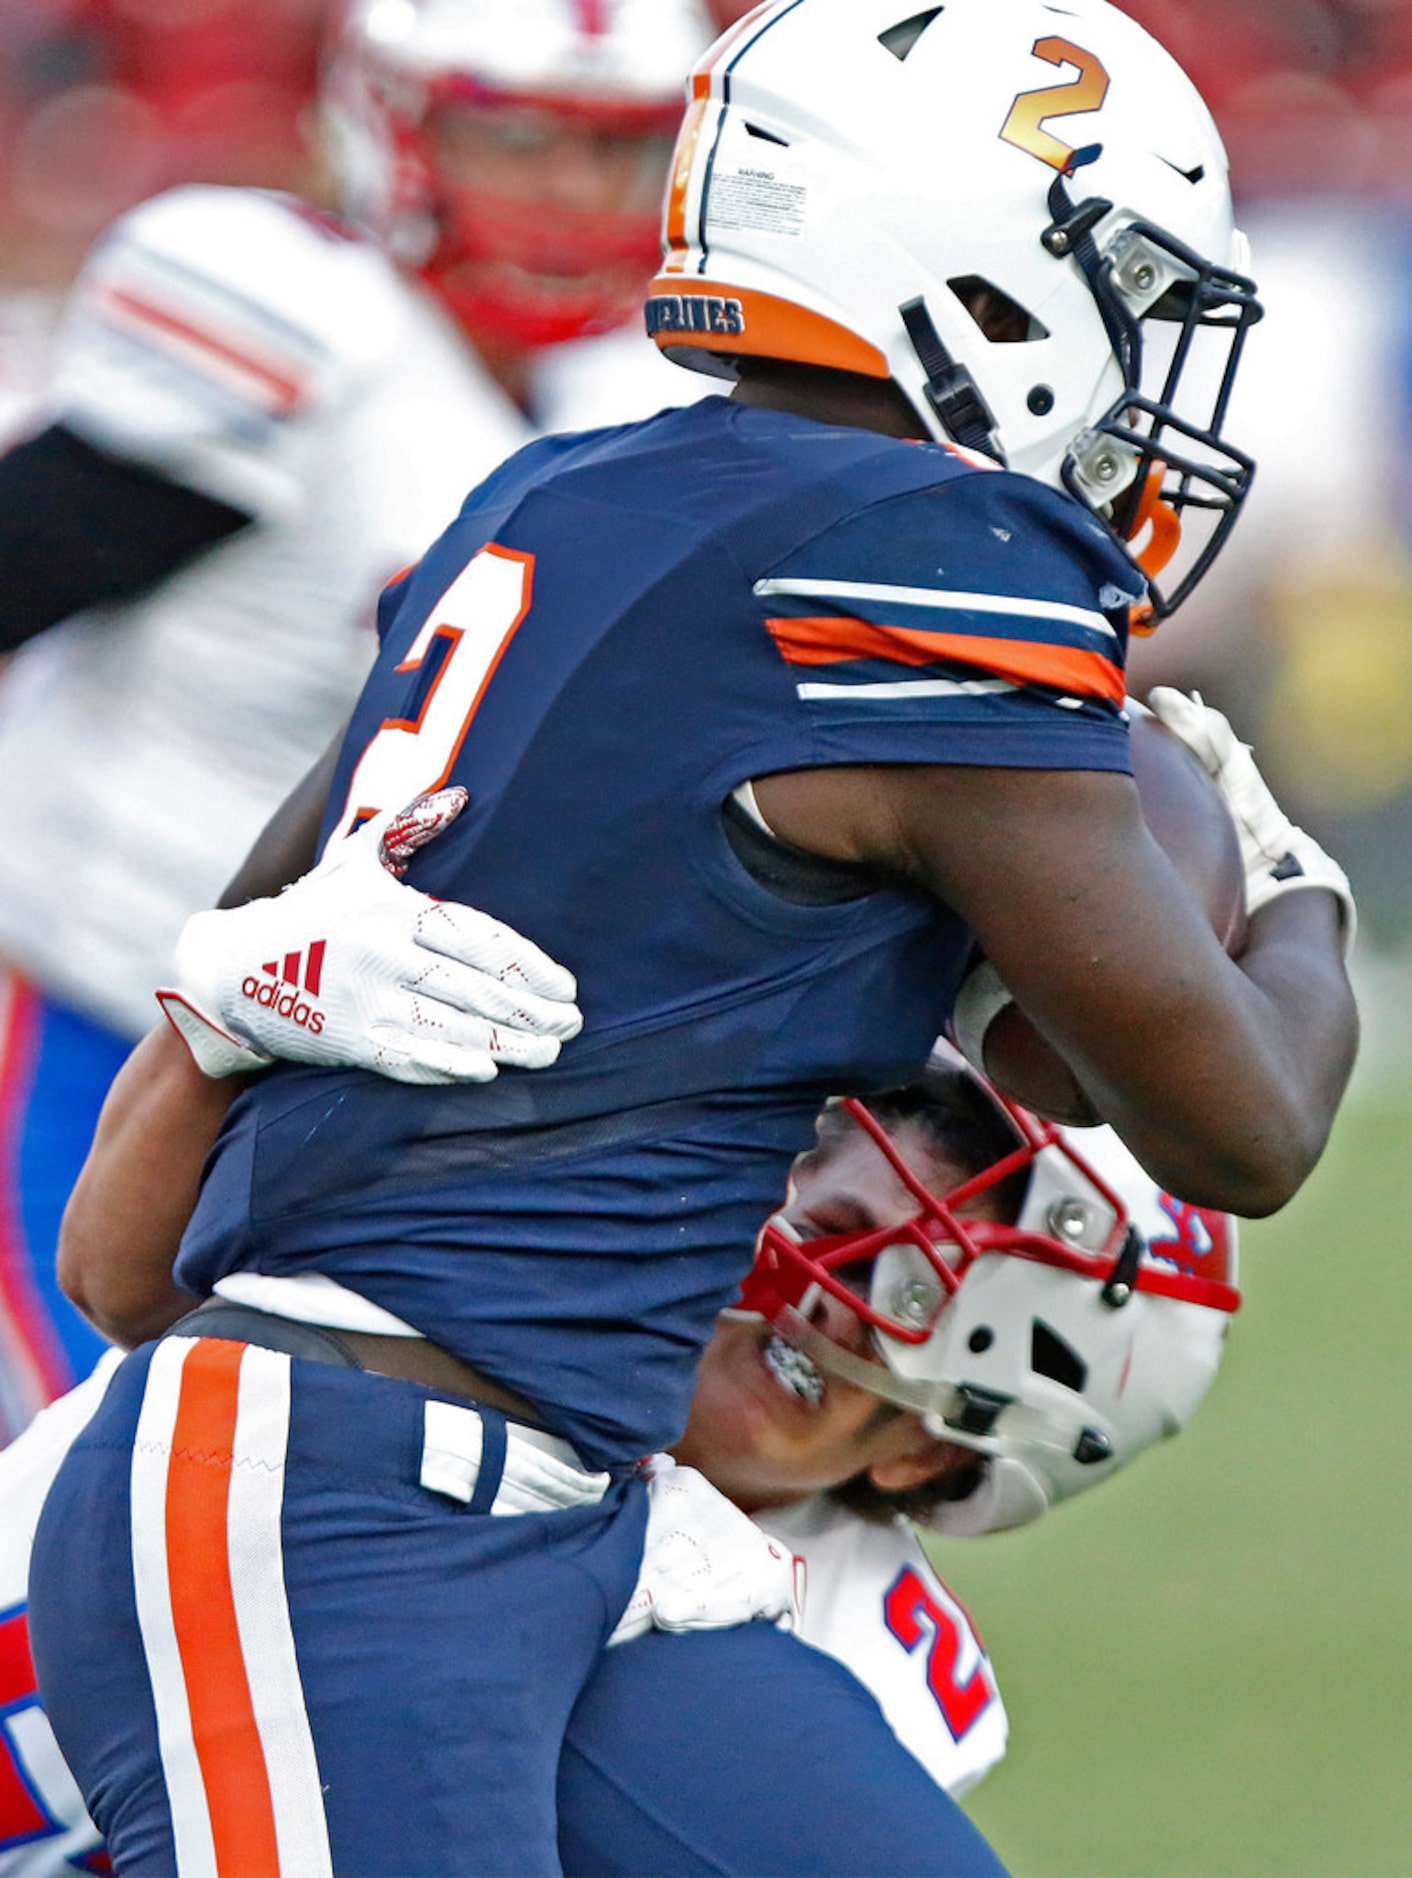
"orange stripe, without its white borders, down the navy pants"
167,1337,280,1878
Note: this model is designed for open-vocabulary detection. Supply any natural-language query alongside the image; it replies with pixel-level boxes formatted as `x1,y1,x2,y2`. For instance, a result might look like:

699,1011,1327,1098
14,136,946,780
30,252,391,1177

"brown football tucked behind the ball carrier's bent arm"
984,699,1245,1127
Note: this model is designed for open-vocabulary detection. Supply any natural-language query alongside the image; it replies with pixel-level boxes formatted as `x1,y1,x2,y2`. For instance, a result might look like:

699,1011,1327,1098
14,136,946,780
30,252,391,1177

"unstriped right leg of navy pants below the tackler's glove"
560,1624,1005,1878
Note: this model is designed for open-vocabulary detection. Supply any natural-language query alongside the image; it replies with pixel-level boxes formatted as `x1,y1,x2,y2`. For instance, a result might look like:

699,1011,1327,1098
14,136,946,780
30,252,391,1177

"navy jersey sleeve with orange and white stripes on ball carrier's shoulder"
755,471,1142,770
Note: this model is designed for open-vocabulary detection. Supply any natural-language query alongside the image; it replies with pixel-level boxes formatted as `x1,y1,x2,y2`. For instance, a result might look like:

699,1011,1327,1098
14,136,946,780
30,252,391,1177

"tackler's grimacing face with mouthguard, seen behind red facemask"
676,1121,973,1512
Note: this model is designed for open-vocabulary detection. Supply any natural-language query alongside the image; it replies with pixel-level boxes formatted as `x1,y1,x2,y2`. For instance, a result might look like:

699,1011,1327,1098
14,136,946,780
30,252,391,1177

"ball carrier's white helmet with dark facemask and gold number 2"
648,0,1260,616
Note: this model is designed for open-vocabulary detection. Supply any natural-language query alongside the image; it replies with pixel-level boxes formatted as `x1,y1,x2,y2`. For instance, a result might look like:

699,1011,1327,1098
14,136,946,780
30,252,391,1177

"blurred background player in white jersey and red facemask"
0,0,710,1439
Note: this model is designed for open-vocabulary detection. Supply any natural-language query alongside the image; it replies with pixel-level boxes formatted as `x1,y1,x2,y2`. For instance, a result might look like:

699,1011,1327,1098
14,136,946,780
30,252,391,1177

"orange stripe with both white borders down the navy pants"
131,1337,332,1878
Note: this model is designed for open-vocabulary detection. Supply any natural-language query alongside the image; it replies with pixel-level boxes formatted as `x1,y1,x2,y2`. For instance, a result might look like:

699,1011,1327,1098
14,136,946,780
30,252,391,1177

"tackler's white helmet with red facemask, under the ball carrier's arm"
742,1078,1239,1536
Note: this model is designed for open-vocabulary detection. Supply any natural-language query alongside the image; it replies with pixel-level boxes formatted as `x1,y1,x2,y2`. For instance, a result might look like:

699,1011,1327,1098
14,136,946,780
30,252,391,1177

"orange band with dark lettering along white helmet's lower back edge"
648,274,892,377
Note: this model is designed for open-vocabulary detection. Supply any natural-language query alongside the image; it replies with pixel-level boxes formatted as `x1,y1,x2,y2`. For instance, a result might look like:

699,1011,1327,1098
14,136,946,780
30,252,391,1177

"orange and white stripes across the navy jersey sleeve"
755,578,1125,704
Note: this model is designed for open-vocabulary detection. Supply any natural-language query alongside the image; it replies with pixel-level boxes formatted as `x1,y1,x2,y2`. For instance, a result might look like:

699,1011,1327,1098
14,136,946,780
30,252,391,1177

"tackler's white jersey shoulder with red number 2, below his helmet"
757,1495,1008,1795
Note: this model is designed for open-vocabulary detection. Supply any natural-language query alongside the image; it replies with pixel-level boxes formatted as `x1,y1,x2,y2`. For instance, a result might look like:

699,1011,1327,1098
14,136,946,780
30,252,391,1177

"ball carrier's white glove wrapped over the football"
1147,685,1358,954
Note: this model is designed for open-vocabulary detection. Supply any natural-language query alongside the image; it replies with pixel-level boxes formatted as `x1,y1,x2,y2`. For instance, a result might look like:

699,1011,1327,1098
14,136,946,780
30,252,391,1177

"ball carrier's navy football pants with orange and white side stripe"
30,1339,999,1878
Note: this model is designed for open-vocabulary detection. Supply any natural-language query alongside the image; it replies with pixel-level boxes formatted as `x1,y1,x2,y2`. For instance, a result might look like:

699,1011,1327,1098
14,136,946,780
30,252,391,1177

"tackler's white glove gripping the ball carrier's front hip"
608,1454,804,1647
